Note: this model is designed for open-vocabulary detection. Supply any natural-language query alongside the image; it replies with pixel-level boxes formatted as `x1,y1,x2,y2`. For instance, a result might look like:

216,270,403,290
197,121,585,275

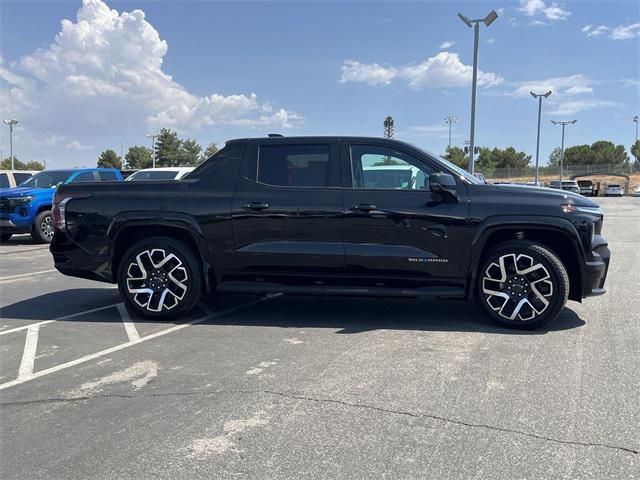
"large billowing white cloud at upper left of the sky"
0,0,302,144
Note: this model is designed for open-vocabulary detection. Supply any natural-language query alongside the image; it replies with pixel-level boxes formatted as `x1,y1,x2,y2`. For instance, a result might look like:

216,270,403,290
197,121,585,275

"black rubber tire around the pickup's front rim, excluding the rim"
476,241,569,330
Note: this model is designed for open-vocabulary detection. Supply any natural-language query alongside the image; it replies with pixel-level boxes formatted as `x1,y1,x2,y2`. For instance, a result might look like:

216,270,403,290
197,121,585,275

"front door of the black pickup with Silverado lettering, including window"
342,144,469,287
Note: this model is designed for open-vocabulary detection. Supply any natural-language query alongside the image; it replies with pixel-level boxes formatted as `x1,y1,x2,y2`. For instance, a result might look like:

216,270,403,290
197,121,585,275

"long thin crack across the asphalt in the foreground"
0,389,640,455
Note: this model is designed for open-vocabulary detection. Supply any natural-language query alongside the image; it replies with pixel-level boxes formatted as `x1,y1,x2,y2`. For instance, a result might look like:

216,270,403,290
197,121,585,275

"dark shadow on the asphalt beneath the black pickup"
0,288,585,335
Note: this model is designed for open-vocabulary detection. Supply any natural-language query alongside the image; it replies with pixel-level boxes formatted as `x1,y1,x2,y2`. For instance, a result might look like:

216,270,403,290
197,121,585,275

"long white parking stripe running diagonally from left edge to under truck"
0,295,278,390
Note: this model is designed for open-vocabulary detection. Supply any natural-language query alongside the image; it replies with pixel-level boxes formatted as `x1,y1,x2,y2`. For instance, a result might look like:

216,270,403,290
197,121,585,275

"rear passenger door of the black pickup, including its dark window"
233,140,344,283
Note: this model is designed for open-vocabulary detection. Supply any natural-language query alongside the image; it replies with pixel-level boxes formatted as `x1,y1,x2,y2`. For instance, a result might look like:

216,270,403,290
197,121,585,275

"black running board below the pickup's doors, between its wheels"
217,281,465,298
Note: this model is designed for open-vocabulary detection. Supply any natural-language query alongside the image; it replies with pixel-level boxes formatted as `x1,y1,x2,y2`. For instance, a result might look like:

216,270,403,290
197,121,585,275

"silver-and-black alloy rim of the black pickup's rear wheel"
126,248,189,312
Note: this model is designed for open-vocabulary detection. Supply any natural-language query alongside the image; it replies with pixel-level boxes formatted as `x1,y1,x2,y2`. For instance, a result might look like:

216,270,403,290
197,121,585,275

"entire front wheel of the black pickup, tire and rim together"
477,240,569,330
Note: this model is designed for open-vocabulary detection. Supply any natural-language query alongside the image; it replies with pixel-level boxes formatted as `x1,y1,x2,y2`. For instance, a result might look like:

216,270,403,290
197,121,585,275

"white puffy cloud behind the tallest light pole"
340,52,503,89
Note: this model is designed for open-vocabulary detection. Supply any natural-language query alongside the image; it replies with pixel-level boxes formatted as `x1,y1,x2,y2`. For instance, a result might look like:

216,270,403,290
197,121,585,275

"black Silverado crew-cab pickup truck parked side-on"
51,137,609,328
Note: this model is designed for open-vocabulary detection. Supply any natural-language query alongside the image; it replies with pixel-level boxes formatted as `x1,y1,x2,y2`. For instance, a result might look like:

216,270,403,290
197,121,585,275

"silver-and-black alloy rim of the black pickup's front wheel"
482,253,554,321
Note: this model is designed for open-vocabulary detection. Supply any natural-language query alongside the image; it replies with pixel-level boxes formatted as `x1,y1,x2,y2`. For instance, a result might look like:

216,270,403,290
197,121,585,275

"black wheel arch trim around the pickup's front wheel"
468,217,584,301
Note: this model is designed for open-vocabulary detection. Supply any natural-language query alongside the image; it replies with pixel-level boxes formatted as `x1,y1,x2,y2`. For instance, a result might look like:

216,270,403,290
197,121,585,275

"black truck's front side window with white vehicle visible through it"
351,145,432,190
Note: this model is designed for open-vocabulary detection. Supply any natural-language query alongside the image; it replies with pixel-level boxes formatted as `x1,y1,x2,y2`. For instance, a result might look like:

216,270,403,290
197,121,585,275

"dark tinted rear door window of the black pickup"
257,144,337,187
